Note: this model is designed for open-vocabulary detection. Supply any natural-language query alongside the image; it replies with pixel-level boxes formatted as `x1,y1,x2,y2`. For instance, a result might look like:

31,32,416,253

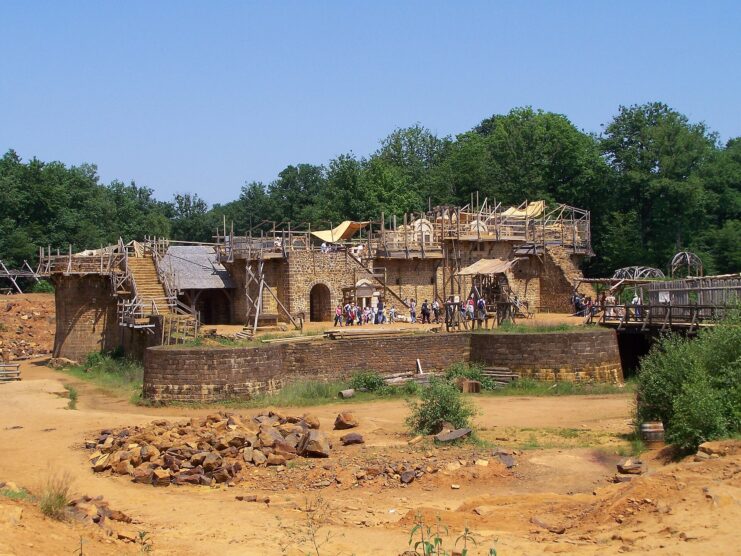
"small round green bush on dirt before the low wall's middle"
406,380,475,434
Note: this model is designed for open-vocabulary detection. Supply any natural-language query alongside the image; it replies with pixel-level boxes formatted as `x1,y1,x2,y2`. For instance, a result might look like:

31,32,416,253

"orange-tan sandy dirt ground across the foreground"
0,362,741,555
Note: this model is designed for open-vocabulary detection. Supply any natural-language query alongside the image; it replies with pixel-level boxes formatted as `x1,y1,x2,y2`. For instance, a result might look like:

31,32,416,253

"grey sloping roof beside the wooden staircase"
162,245,234,290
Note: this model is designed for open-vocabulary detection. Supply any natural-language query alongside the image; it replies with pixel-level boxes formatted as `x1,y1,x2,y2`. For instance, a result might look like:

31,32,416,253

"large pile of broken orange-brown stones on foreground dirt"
85,410,331,486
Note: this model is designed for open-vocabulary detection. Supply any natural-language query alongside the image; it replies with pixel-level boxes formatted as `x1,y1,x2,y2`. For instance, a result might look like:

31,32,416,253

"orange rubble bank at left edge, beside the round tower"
0,294,55,362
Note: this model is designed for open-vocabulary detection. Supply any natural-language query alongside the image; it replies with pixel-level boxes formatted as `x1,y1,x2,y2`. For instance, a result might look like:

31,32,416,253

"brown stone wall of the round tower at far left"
54,275,121,361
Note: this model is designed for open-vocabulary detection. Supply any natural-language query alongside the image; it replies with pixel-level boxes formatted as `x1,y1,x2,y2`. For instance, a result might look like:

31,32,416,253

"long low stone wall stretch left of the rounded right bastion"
144,334,470,401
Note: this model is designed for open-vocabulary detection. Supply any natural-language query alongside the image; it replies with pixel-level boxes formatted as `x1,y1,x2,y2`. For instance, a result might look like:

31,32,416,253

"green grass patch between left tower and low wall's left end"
56,353,144,402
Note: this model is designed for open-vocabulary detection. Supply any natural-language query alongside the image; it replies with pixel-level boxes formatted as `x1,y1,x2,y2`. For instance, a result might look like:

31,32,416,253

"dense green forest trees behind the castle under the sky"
0,103,741,276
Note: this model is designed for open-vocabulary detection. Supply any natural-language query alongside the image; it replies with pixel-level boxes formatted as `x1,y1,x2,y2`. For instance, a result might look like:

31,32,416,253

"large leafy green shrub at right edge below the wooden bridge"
637,311,741,451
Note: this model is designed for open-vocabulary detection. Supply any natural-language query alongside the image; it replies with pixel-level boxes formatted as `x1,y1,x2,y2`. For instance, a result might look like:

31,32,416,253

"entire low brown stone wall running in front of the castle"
144,330,622,402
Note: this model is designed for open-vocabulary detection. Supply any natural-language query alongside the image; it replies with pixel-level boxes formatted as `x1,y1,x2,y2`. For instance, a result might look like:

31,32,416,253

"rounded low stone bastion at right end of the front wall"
471,328,623,382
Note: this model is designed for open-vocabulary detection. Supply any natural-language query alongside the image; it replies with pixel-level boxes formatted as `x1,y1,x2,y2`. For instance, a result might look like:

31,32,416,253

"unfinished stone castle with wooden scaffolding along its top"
37,200,593,360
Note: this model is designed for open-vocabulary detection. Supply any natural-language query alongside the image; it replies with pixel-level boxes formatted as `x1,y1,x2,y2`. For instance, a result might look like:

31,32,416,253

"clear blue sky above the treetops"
0,0,741,203
